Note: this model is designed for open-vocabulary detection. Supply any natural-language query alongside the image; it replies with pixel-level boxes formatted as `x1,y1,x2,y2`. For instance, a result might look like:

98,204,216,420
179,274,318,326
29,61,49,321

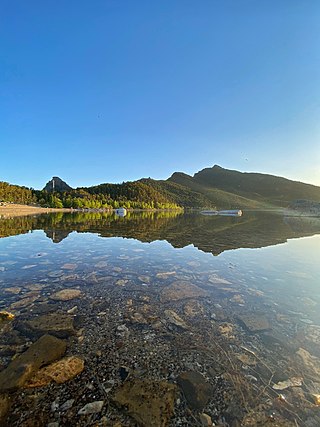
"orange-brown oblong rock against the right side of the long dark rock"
25,356,84,388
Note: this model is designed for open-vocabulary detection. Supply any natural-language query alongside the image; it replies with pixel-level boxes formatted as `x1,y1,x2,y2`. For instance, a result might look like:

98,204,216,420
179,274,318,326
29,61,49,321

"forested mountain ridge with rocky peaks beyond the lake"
0,165,320,209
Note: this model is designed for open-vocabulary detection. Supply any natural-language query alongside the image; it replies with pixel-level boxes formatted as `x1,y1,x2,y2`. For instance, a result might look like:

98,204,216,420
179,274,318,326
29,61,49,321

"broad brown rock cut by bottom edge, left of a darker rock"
114,379,177,427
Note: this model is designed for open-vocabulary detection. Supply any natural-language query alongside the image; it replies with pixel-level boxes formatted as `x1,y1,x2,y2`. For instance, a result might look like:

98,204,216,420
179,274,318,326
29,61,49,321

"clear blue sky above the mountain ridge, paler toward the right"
0,0,320,188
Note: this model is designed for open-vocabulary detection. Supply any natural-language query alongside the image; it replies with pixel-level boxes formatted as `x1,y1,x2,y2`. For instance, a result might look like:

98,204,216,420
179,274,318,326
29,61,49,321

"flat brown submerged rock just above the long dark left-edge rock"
24,313,75,338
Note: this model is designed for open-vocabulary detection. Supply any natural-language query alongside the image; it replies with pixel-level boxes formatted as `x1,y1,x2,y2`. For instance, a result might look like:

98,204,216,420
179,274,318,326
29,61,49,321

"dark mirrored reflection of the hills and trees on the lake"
0,211,320,255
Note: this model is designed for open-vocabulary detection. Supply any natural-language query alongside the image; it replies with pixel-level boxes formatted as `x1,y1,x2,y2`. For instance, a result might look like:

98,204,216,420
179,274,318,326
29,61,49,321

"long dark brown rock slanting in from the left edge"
0,335,67,393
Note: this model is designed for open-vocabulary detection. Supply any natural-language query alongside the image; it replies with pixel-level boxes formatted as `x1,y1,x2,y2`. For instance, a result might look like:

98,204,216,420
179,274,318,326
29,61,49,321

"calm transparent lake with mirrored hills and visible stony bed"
0,212,320,427
